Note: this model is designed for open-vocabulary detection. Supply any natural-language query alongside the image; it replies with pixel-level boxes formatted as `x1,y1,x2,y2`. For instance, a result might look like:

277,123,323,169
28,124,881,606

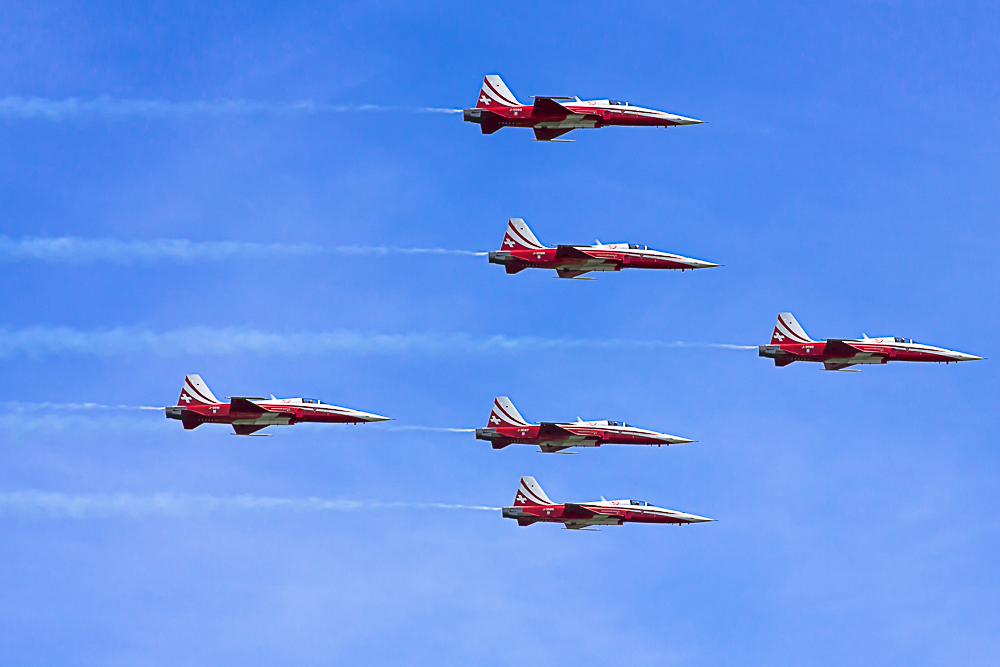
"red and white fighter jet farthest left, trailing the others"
167,375,389,435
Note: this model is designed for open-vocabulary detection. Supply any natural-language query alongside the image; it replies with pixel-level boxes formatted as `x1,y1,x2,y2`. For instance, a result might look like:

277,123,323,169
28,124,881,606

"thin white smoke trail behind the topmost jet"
0,95,462,121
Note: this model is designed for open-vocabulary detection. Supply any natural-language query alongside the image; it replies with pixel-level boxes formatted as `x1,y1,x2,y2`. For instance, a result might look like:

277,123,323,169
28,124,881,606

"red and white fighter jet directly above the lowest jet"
476,396,694,453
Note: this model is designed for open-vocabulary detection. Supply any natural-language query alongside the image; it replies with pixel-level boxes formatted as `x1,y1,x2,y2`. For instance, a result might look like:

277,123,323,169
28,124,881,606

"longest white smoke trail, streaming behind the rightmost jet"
0,327,756,358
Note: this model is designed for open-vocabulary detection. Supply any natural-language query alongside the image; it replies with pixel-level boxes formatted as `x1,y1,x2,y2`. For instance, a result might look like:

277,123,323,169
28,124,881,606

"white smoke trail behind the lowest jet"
0,491,500,519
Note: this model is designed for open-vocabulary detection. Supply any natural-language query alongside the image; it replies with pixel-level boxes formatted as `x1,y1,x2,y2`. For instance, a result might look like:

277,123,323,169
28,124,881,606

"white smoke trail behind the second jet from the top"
0,236,489,264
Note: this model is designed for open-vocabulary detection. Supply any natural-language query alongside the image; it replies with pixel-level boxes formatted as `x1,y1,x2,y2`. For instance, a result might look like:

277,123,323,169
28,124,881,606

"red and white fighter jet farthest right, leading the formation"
758,313,982,372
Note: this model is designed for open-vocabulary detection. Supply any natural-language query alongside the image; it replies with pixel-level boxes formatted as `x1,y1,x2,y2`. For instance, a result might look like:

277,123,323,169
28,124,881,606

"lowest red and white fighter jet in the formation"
503,477,714,530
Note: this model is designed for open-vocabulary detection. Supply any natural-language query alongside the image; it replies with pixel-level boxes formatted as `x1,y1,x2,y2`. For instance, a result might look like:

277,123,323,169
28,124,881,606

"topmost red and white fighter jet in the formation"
463,74,702,141
